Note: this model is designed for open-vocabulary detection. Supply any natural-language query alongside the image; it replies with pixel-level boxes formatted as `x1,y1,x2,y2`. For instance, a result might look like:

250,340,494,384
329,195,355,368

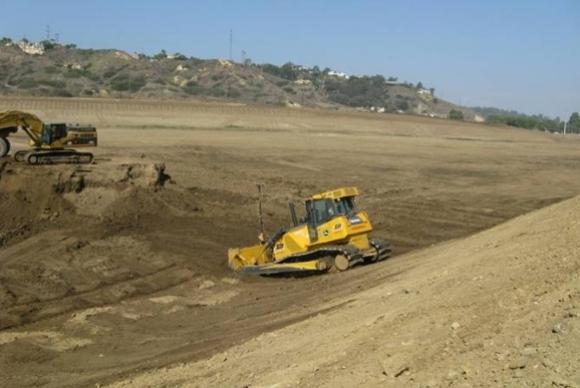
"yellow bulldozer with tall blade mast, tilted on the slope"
228,186,391,275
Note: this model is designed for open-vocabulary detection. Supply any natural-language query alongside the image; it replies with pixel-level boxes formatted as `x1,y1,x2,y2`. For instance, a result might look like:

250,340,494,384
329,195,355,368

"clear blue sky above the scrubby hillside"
0,0,580,118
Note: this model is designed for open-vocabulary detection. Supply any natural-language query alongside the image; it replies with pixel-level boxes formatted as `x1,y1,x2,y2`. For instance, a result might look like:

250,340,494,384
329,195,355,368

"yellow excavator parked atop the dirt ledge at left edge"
0,110,97,164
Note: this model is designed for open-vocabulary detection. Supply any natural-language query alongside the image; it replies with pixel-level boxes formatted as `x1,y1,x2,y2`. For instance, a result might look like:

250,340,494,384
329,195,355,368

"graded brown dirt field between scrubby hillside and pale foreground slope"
0,98,580,387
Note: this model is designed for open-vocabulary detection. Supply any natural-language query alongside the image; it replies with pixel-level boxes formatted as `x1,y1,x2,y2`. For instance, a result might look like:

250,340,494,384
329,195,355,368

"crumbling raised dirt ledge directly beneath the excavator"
0,160,171,239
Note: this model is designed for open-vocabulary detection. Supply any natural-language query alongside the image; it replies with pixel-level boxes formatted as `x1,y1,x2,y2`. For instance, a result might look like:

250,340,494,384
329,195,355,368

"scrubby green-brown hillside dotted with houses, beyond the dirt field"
0,38,474,120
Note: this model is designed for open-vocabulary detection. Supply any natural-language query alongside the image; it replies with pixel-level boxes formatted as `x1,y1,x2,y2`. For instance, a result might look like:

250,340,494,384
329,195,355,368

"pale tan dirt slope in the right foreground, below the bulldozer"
113,197,580,387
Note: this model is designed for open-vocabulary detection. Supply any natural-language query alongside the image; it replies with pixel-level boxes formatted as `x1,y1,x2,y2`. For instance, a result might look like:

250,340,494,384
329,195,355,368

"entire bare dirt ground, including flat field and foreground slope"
0,98,580,387
